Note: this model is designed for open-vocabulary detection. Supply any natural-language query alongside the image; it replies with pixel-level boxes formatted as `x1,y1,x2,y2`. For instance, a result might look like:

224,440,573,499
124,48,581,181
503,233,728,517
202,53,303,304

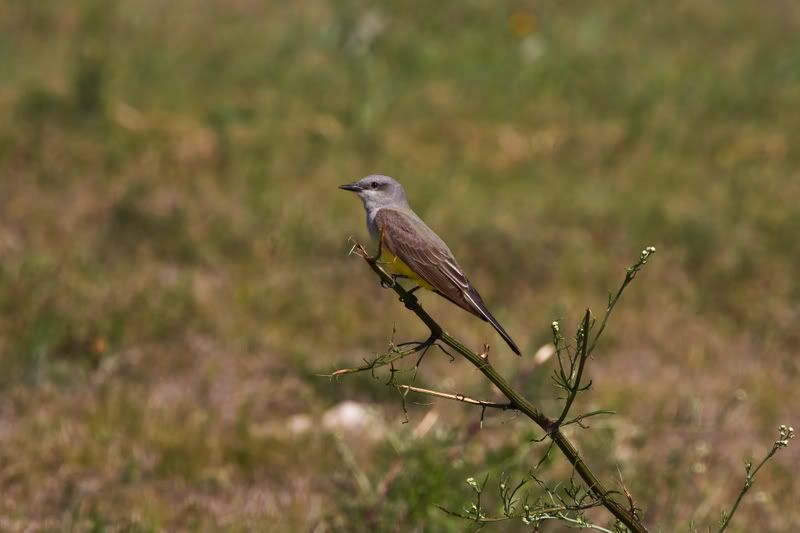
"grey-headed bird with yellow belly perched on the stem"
339,174,522,355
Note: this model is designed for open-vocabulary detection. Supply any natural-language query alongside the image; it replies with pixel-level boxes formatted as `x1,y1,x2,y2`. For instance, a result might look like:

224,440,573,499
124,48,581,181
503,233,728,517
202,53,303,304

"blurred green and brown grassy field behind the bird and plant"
0,0,800,532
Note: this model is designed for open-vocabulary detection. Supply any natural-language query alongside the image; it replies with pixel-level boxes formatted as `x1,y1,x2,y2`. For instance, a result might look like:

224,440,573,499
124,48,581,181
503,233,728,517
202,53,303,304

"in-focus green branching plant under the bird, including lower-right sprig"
329,244,794,533
